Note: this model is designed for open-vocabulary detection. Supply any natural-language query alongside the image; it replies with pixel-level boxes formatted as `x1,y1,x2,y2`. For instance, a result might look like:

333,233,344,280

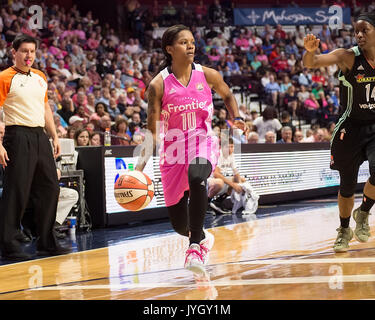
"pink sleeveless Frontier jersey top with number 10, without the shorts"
160,63,216,165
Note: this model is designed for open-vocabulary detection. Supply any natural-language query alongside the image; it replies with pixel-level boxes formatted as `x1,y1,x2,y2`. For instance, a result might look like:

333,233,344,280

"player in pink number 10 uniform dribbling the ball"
136,25,245,272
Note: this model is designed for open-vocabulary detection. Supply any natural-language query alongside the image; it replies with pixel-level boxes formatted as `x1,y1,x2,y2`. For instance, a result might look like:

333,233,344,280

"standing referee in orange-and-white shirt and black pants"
0,34,70,260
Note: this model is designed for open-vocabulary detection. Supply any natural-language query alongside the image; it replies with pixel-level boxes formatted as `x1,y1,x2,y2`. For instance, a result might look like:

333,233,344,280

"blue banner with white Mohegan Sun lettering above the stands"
234,6,351,29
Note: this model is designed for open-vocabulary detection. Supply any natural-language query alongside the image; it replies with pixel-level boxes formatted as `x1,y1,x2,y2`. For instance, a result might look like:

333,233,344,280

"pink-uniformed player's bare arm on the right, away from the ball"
203,67,246,131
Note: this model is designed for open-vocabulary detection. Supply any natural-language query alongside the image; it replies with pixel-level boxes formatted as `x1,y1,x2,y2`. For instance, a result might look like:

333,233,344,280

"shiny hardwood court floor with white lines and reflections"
0,203,375,300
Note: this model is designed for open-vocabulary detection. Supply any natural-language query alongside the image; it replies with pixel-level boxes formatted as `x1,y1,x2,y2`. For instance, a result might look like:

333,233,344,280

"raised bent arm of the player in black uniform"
302,34,354,72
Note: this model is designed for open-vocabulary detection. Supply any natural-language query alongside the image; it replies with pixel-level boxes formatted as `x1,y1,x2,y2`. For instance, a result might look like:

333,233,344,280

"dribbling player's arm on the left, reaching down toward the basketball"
135,75,163,171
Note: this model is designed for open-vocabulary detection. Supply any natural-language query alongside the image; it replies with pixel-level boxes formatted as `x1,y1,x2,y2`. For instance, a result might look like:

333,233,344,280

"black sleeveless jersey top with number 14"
339,46,375,123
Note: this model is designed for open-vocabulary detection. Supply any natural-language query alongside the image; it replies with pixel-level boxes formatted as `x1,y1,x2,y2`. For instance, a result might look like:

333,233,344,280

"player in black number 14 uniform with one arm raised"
303,13,375,252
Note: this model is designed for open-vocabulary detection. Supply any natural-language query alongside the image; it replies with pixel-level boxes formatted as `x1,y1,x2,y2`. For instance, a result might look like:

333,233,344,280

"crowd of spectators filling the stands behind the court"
0,0,375,146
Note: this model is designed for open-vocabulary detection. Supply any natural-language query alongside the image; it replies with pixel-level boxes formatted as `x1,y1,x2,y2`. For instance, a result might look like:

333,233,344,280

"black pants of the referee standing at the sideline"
0,126,59,252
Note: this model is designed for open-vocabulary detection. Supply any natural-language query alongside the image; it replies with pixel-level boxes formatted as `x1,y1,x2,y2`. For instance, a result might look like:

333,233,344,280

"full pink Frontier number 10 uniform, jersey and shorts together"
159,63,219,206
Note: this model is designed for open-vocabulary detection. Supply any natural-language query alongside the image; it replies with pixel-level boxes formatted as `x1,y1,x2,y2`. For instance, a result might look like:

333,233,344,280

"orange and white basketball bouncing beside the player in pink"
114,171,154,211
